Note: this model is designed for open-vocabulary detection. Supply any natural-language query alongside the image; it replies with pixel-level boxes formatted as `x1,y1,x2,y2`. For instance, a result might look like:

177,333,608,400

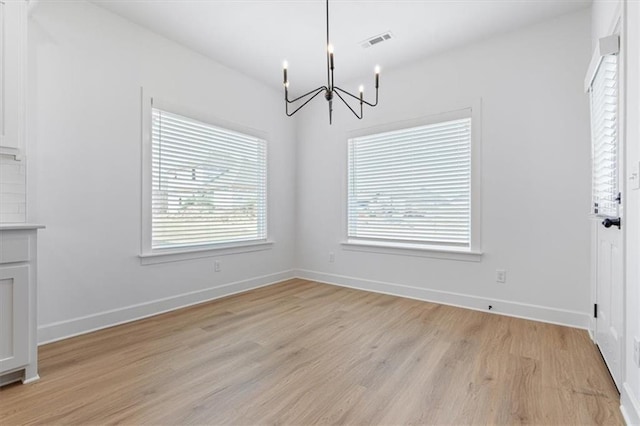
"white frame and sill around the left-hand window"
138,88,273,265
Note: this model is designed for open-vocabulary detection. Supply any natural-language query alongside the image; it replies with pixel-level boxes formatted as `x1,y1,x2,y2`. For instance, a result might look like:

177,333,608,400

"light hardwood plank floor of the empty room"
0,280,623,426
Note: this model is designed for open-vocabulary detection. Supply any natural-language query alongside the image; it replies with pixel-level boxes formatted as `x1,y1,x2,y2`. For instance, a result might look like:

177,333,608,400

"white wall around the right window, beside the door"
297,10,591,327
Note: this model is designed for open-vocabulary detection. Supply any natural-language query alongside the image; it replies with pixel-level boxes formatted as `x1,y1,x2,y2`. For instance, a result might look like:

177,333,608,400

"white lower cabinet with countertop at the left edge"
0,224,41,386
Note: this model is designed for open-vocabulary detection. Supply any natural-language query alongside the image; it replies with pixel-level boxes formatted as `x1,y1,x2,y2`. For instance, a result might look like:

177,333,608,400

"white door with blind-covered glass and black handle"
591,50,624,388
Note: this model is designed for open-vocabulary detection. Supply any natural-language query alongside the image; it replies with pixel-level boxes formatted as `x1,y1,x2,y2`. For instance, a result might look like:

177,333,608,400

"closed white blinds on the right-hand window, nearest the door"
347,117,471,248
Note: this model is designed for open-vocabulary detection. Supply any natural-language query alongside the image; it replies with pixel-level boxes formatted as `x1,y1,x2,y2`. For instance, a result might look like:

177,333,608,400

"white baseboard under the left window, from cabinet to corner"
38,270,296,345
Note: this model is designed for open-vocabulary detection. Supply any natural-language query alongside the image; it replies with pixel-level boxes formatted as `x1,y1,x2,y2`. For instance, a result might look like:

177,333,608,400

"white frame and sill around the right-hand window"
341,99,482,262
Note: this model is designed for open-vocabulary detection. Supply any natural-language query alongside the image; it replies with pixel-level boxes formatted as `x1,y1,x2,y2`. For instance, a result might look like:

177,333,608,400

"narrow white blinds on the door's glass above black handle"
590,55,618,216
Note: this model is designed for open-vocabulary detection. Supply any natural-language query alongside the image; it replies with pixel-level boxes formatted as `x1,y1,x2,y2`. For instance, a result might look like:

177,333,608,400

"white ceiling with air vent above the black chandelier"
91,0,591,95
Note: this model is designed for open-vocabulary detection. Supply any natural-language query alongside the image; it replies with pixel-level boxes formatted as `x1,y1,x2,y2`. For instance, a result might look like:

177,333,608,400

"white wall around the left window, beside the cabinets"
28,1,295,342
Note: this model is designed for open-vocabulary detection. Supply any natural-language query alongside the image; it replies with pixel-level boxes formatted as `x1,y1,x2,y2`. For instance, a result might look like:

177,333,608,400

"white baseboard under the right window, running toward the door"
296,269,591,329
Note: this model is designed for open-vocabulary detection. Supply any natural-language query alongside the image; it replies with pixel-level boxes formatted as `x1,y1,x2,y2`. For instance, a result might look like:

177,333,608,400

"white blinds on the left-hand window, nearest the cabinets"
151,108,267,249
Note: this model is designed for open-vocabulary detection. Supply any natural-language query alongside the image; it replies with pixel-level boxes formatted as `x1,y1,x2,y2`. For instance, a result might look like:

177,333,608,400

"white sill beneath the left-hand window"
138,241,273,265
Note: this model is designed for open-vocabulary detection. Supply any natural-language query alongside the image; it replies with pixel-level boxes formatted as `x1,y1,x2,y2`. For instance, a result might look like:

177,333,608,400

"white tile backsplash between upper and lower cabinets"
0,155,27,223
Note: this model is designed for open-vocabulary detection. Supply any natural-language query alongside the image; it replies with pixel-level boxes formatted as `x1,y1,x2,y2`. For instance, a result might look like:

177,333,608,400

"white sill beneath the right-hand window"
342,241,482,262
